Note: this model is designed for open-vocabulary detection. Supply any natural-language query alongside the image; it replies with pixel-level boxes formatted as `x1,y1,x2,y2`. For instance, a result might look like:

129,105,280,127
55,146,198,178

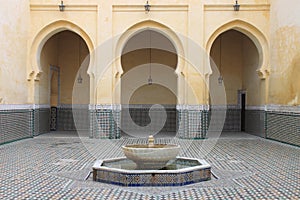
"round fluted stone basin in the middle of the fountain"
122,144,180,170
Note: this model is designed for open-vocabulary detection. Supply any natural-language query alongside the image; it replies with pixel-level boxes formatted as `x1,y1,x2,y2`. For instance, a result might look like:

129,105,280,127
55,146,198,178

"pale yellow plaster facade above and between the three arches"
27,0,269,108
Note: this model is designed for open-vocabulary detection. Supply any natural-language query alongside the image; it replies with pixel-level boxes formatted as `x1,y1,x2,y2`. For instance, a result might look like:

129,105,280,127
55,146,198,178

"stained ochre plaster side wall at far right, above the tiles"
269,0,300,105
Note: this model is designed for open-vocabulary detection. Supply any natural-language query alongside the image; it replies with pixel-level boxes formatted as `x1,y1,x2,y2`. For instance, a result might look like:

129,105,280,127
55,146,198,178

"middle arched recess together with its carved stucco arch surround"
115,21,184,137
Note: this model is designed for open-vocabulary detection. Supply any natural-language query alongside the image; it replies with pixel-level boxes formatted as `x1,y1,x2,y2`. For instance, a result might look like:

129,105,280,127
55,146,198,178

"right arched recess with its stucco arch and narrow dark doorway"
206,20,269,136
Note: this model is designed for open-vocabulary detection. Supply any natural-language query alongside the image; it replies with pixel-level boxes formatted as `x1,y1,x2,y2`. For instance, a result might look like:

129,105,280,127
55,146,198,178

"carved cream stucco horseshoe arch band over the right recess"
206,20,270,79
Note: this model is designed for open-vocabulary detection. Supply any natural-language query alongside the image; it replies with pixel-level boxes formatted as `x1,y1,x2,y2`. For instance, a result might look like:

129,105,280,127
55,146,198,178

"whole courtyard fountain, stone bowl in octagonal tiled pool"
93,136,211,186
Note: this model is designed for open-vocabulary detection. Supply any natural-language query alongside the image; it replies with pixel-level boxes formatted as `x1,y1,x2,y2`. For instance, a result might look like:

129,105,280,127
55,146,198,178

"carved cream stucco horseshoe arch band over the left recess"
27,20,94,80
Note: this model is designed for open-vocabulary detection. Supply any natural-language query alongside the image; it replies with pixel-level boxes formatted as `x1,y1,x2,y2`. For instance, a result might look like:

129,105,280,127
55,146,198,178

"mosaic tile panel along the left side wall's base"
0,110,33,144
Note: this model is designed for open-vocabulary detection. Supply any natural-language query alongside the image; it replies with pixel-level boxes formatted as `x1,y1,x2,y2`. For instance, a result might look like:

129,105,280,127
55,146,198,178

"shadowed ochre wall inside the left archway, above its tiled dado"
39,31,89,104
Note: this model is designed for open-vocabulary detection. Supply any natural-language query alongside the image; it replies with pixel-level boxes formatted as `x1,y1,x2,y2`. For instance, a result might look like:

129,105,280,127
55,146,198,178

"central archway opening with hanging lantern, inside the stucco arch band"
121,28,178,137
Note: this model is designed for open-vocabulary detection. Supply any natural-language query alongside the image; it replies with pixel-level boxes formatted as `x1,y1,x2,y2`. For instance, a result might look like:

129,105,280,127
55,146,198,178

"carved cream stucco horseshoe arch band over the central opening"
115,20,185,76
